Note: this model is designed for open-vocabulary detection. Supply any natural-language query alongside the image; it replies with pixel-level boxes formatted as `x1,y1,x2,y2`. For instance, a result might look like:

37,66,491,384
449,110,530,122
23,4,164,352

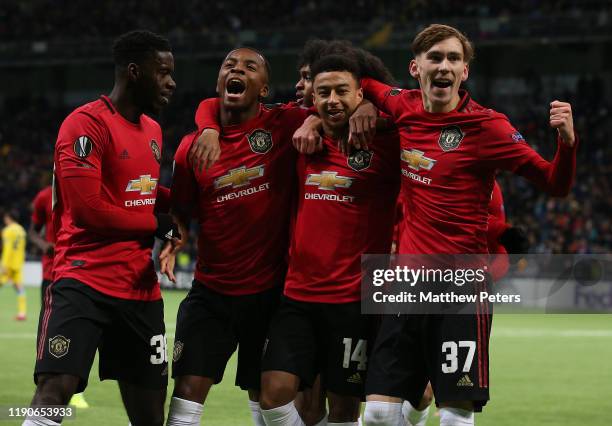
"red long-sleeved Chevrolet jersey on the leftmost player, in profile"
53,97,162,300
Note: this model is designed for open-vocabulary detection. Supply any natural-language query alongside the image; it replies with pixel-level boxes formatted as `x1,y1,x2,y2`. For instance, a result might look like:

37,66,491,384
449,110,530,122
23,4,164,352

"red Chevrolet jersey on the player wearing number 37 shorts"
362,79,577,254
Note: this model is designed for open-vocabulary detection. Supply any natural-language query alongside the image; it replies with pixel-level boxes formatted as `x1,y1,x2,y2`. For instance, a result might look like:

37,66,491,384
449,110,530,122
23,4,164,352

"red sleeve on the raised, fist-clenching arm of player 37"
479,117,578,196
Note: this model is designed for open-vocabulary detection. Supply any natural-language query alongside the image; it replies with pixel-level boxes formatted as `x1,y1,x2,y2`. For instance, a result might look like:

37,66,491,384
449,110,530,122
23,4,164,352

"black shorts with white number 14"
262,297,375,398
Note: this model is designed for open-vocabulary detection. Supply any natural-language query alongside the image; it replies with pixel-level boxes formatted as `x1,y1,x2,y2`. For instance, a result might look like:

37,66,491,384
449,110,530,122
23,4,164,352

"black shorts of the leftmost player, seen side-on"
34,279,168,392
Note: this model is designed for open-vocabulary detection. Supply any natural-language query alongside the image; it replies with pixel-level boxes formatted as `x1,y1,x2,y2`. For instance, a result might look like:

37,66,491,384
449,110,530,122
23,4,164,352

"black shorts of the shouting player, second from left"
172,281,281,390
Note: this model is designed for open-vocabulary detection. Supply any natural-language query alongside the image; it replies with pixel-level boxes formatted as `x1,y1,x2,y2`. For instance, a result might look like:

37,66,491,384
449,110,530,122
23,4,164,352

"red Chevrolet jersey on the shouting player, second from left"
171,100,307,295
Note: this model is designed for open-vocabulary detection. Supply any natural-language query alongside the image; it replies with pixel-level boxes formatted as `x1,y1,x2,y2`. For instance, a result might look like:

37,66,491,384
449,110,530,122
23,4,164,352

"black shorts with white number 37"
366,305,493,411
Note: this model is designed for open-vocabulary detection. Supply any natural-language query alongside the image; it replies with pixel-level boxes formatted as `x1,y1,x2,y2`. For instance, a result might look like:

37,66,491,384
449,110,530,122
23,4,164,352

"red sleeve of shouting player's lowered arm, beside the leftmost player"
170,133,198,212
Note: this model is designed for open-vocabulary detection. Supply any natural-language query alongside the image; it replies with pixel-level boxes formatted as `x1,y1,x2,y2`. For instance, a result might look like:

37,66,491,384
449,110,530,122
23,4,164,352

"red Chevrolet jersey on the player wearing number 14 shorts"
285,131,400,303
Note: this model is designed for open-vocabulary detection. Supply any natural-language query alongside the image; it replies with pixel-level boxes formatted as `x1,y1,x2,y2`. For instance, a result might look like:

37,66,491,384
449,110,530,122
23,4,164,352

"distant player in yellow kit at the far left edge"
0,211,26,321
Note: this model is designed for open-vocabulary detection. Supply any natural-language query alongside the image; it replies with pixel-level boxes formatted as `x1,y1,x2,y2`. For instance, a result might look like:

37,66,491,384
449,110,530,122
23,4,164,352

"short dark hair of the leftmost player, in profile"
113,30,172,66
